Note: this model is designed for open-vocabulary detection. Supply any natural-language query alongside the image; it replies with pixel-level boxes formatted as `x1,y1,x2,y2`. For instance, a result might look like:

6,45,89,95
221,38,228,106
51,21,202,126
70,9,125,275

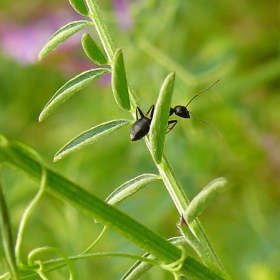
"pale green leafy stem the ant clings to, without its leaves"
86,0,230,276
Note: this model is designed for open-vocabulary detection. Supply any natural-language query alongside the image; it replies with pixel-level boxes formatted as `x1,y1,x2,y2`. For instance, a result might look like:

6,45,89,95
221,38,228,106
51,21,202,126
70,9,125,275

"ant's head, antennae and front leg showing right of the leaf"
167,79,222,137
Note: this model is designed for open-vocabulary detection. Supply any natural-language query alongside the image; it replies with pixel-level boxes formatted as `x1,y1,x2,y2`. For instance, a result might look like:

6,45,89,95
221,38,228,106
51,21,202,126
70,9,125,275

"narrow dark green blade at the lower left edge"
0,184,19,279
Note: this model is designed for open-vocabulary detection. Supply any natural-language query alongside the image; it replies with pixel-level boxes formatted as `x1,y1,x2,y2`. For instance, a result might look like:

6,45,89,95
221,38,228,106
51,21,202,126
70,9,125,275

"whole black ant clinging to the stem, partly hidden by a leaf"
130,80,221,141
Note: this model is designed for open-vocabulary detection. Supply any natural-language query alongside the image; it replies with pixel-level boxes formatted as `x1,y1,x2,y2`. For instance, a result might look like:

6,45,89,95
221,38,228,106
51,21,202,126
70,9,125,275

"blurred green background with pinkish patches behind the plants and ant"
0,0,280,280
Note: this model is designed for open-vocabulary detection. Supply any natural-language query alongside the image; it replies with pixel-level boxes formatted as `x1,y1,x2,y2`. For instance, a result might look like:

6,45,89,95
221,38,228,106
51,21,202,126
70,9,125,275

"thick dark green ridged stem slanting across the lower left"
0,138,223,280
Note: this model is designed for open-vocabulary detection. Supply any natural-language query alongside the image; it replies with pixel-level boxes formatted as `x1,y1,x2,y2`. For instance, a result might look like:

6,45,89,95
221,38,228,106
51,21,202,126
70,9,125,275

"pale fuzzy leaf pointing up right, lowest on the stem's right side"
184,178,227,223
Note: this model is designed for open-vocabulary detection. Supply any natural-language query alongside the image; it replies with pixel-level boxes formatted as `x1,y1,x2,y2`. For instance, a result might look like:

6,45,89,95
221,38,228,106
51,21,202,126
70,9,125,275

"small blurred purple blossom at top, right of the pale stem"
114,0,133,30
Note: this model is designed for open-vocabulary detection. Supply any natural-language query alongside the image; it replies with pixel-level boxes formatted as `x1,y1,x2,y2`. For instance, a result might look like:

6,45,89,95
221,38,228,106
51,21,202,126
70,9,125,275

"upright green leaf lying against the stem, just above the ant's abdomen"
112,49,130,111
